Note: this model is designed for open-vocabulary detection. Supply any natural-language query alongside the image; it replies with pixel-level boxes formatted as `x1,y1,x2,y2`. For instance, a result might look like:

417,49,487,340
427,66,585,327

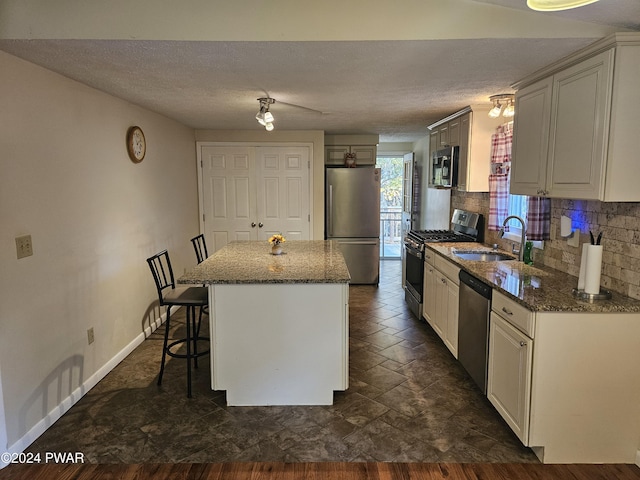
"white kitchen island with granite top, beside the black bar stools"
178,240,350,405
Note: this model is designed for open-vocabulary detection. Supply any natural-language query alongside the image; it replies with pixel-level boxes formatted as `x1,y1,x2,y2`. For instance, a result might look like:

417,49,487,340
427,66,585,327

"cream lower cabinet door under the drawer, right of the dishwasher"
487,312,533,446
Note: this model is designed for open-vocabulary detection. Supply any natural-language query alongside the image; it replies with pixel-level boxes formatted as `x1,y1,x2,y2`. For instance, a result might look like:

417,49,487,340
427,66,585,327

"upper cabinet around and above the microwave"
429,106,506,192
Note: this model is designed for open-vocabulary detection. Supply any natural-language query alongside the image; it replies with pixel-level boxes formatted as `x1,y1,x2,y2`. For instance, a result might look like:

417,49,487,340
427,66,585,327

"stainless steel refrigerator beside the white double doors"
325,167,380,285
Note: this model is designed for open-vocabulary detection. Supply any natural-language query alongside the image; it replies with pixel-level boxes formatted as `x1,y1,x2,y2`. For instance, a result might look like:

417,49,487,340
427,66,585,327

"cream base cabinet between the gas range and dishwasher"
422,253,460,358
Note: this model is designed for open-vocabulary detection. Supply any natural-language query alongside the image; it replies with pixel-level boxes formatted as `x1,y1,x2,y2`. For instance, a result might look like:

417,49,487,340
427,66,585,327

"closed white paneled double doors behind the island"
198,144,311,254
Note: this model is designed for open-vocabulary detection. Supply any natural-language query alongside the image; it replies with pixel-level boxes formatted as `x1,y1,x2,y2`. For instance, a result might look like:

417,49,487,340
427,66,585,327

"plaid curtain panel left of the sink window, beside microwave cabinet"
487,122,513,231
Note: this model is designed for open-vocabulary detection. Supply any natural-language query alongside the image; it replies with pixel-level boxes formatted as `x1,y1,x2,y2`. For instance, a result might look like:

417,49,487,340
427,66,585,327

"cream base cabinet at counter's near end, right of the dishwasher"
487,289,640,463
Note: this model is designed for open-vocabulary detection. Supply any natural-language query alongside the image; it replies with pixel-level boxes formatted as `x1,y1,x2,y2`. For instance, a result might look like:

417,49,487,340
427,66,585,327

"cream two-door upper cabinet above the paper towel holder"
511,33,640,202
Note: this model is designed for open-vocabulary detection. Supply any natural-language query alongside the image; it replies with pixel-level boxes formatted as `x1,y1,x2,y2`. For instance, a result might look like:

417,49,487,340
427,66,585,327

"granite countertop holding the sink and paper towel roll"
426,243,640,313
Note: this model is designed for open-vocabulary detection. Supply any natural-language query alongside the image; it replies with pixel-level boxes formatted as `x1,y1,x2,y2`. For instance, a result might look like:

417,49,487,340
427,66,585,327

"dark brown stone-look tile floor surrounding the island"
28,260,537,463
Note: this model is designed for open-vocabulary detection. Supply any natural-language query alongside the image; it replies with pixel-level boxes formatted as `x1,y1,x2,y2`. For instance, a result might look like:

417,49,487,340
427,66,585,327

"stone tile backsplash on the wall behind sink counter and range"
451,191,640,299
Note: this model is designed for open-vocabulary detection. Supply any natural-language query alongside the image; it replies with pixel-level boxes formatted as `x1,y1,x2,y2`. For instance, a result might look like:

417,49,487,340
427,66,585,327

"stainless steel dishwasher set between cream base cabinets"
458,270,491,394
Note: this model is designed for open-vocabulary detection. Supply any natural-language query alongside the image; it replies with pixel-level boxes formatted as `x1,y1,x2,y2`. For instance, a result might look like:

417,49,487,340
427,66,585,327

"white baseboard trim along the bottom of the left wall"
0,313,166,469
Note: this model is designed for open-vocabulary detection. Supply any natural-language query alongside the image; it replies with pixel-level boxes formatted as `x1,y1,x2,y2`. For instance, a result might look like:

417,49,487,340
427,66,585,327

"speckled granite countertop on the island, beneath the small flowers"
178,240,351,285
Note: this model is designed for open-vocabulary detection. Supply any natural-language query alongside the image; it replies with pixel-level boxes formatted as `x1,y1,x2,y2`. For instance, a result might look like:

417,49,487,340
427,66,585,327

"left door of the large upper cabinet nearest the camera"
510,78,553,196
